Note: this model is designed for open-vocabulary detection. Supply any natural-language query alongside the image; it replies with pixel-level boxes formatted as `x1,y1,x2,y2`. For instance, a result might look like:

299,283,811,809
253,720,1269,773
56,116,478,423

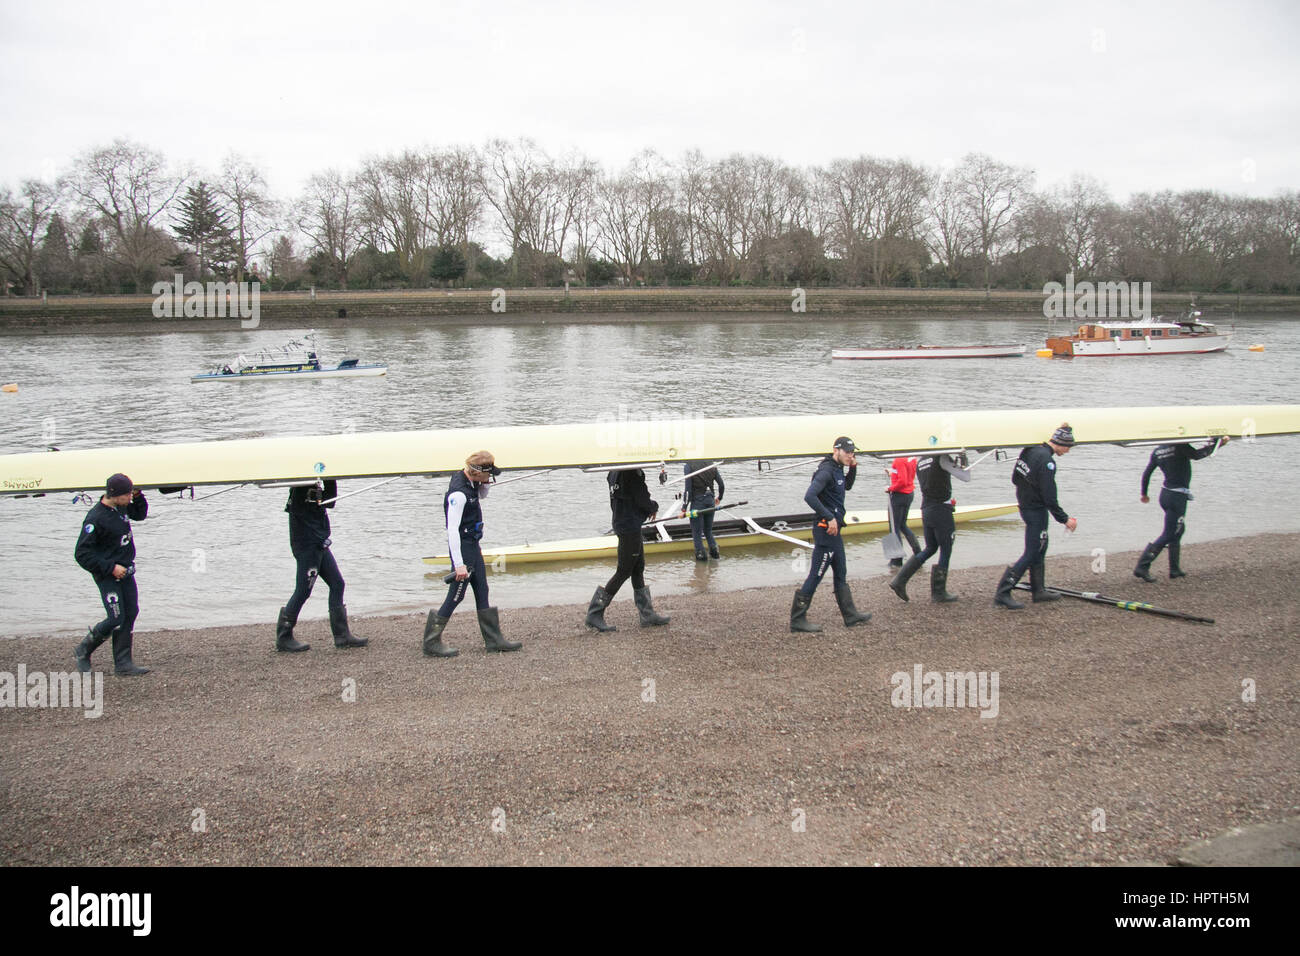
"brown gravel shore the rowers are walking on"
0,535,1300,865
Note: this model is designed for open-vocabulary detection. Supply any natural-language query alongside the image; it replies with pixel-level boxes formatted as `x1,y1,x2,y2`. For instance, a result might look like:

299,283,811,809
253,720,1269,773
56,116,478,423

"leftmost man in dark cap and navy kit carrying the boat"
73,475,150,676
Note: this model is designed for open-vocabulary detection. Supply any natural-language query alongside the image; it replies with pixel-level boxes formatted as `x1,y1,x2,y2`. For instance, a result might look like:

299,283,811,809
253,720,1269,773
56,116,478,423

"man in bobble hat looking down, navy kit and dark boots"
993,421,1079,611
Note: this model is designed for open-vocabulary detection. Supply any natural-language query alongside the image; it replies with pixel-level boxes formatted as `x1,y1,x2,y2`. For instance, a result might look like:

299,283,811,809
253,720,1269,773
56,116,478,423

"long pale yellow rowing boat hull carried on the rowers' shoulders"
0,405,1300,494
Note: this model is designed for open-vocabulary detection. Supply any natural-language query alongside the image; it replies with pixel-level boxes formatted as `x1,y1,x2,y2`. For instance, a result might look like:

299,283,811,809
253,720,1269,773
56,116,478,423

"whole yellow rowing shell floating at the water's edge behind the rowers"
424,505,1015,564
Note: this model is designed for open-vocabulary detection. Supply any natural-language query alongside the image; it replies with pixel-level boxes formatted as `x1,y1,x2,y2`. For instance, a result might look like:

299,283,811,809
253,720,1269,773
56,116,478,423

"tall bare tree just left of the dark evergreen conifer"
62,139,189,287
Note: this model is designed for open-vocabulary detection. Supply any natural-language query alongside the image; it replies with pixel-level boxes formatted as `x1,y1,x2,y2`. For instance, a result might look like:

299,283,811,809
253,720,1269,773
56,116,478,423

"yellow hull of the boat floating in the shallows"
424,505,1015,567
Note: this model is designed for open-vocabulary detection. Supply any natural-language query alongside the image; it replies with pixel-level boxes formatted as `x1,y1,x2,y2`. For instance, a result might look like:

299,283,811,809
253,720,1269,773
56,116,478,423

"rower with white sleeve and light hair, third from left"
423,451,514,657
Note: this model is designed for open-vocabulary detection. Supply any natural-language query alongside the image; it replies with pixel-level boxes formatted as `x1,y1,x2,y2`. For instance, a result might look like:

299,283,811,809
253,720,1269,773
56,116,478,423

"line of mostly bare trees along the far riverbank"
0,139,1300,295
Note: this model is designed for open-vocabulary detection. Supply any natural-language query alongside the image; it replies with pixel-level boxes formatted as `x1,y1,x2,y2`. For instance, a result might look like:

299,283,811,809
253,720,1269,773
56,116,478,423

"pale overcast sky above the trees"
0,0,1300,200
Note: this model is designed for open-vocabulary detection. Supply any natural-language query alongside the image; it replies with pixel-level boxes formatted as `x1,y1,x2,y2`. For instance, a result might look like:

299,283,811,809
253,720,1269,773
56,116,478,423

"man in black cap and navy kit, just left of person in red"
790,436,871,633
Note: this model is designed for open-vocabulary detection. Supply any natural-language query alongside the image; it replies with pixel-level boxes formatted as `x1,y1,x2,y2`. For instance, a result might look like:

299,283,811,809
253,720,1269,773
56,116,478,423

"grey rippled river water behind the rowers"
0,316,1300,643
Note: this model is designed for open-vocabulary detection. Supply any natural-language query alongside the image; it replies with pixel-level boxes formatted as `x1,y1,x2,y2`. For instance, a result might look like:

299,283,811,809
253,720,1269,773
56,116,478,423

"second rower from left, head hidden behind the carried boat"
276,480,369,652
